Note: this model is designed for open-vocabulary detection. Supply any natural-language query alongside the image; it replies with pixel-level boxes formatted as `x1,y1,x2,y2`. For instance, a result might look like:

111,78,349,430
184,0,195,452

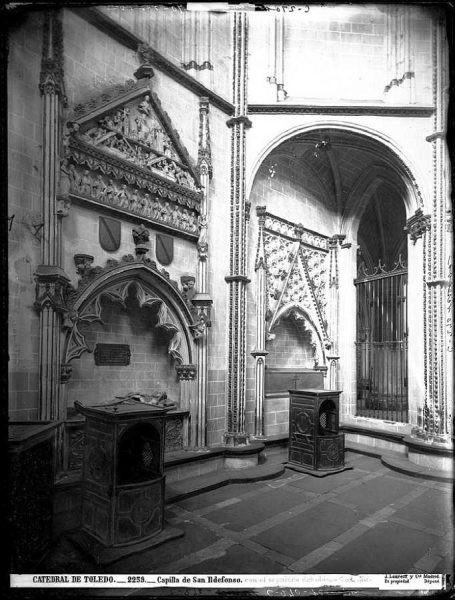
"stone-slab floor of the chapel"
40,453,453,596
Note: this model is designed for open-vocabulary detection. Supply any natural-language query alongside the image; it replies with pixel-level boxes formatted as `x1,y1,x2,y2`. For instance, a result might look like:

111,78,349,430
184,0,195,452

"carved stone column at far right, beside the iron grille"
416,14,453,444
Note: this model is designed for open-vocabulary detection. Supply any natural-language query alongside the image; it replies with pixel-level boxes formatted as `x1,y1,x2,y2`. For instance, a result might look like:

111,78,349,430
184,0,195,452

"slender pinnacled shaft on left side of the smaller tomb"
251,206,268,439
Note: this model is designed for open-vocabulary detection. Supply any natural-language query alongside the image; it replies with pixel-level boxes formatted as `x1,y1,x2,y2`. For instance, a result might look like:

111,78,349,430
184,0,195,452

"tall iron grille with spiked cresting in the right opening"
354,256,408,422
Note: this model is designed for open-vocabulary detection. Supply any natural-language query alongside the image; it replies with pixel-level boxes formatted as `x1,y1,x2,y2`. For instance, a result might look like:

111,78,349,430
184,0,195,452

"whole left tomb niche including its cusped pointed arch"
64,262,196,410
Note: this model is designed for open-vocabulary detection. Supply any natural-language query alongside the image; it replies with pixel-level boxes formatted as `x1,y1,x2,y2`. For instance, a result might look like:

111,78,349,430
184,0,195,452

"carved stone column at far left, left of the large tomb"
36,11,68,420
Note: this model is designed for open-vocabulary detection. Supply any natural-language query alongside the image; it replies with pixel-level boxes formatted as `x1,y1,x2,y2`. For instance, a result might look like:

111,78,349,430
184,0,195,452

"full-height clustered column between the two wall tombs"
225,11,251,445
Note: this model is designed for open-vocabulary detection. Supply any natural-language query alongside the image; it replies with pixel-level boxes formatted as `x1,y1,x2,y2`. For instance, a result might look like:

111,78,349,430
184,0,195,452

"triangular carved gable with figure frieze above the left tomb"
62,79,202,239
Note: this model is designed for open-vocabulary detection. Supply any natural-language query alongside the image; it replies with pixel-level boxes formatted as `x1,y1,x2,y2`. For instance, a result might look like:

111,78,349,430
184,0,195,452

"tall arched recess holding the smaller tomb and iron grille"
247,123,424,436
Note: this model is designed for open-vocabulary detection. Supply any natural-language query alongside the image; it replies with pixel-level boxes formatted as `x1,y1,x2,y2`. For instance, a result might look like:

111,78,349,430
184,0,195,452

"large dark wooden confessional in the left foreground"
71,402,183,564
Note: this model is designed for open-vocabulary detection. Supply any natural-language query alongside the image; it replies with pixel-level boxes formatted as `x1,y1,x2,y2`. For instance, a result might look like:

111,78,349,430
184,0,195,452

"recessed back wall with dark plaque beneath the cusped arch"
68,283,179,405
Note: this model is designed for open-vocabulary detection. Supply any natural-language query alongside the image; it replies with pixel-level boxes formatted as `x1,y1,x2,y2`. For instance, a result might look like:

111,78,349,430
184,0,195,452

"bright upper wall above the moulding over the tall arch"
249,4,431,103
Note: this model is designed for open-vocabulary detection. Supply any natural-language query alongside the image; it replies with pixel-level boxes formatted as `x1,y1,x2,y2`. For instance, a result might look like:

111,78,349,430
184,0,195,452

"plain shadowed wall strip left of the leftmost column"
7,12,42,420
